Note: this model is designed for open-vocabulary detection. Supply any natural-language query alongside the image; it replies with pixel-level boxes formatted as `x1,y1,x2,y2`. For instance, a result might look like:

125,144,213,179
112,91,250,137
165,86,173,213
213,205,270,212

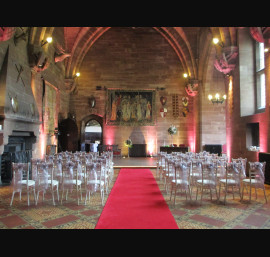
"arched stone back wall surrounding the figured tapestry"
70,28,194,155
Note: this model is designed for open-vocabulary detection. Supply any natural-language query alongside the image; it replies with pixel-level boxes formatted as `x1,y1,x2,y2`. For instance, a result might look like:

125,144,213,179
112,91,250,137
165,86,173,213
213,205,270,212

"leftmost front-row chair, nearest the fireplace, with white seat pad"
10,163,36,206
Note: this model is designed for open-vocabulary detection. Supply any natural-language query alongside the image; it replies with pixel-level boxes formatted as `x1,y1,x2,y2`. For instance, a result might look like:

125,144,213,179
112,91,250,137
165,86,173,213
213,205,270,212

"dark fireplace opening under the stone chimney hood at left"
0,131,36,184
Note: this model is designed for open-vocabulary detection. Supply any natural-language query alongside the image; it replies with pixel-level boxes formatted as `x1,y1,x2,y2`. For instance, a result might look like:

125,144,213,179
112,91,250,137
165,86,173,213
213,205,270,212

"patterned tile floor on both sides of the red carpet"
0,169,270,229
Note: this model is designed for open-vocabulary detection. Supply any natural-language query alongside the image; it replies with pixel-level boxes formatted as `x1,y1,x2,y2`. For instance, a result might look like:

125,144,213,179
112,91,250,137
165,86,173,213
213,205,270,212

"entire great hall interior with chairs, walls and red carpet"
0,27,270,229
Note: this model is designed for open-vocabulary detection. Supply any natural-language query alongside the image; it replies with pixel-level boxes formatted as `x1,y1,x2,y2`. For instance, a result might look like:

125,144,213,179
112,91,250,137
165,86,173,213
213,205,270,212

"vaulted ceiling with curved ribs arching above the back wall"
29,27,244,79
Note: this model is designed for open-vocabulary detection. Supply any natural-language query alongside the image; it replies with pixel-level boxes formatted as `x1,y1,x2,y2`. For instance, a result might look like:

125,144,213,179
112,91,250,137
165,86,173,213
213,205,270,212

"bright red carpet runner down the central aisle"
96,169,178,229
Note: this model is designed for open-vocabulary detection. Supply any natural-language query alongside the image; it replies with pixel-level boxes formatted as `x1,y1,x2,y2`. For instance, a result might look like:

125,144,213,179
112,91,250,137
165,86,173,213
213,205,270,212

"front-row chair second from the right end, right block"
219,162,245,204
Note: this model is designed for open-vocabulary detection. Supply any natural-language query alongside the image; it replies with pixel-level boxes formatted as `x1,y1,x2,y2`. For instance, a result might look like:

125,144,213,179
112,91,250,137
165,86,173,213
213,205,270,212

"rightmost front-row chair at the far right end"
242,162,267,203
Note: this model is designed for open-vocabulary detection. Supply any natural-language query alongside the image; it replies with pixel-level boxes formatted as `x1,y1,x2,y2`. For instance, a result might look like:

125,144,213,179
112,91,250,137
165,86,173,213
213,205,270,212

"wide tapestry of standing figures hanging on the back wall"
106,89,156,126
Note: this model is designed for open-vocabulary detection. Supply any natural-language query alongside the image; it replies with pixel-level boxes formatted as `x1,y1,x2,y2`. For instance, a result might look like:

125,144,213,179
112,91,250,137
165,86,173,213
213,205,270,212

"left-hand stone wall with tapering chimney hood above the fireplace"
0,28,69,157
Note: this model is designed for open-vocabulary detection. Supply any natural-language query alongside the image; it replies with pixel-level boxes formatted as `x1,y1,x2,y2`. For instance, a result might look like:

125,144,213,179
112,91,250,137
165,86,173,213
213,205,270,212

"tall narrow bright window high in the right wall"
255,42,265,111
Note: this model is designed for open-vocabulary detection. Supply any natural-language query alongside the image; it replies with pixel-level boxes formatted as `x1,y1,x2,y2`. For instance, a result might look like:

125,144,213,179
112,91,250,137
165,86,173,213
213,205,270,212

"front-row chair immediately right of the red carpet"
170,161,192,205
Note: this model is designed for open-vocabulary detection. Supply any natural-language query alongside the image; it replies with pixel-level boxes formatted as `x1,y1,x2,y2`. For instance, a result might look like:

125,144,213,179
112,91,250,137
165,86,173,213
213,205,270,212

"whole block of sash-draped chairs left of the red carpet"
10,152,113,206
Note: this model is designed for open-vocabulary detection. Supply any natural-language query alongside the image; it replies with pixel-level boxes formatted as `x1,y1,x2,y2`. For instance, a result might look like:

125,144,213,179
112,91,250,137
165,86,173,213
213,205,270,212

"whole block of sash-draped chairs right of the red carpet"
157,153,267,204
